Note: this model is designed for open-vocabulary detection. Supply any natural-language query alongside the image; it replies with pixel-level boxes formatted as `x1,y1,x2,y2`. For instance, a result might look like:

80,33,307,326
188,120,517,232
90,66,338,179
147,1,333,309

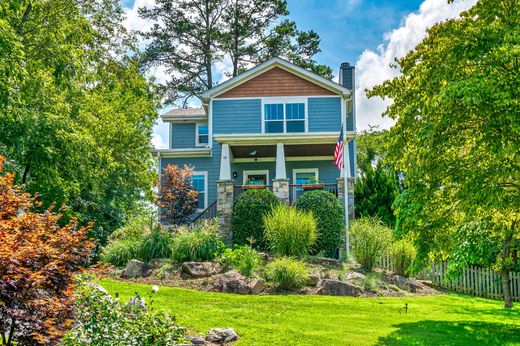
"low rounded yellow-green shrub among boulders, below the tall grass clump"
267,257,310,290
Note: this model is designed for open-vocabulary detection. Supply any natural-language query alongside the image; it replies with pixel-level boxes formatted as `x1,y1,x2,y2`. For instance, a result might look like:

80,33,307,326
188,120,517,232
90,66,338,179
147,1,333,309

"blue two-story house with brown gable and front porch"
154,58,356,235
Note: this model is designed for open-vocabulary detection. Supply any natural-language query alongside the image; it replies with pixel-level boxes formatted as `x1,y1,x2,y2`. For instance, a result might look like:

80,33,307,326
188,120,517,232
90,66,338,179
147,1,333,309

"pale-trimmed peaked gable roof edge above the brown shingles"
202,57,352,100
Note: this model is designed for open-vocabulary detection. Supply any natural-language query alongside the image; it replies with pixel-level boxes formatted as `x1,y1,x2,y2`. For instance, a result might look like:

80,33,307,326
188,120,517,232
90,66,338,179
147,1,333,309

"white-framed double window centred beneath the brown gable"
264,101,306,133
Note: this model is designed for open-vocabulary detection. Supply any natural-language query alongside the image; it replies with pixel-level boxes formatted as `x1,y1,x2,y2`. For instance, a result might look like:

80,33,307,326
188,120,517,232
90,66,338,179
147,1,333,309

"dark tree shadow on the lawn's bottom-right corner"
377,321,520,345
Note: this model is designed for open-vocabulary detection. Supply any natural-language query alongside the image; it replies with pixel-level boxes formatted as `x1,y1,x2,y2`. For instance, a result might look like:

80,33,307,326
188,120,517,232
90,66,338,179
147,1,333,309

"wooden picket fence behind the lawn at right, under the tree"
377,257,520,302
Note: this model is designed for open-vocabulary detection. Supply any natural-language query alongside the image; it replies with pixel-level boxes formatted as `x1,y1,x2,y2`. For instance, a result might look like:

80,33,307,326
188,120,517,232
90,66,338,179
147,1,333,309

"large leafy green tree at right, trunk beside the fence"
369,0,520,306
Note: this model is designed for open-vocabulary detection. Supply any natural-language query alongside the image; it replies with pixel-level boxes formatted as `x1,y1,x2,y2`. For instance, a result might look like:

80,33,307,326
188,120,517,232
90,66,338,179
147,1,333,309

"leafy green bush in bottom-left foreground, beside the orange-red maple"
61,281,185,346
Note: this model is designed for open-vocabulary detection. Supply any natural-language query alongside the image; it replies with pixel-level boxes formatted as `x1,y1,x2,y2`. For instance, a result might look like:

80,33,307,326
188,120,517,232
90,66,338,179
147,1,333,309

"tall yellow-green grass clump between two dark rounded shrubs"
264,204,316,257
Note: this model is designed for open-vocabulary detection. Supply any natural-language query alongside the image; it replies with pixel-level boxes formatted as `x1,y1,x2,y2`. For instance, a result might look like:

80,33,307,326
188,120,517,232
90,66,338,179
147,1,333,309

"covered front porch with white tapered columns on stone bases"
209,133,354,240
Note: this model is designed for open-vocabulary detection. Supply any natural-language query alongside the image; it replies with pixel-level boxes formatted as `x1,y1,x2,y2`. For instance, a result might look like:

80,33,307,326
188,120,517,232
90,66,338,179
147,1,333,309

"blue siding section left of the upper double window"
212,99,262,134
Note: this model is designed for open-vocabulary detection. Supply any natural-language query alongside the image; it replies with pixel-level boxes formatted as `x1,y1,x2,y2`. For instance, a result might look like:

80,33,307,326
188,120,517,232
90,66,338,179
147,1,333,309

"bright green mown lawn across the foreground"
101,280,520,345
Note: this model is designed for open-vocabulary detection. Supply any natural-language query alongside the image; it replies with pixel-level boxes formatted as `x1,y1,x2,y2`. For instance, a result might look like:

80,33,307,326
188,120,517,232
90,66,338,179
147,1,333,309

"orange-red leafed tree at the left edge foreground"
0,157,94,345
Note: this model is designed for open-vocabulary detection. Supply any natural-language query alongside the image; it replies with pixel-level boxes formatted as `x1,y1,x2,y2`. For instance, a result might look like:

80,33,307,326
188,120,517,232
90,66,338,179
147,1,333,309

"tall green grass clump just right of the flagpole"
350,218,392,272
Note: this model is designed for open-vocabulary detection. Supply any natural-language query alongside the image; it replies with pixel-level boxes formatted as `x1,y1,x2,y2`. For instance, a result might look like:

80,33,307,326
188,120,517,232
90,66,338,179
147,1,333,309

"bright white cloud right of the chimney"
356,0,476,130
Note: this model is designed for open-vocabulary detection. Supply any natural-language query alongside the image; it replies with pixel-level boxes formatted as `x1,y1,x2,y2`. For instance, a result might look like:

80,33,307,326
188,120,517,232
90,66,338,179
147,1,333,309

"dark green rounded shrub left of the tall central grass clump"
231,189,278,250
